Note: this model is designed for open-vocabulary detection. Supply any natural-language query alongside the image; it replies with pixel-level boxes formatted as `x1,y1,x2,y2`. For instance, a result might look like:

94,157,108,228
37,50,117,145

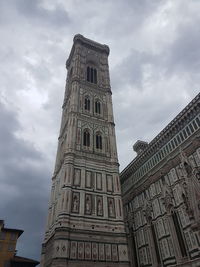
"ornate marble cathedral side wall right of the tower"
120,94,200,267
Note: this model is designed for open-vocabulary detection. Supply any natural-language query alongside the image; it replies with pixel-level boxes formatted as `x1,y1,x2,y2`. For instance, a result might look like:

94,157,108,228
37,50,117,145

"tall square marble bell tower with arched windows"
41,34,129,267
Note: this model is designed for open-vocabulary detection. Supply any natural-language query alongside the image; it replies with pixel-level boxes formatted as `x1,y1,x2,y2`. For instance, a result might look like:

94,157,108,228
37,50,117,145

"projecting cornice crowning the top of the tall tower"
66,34,110,69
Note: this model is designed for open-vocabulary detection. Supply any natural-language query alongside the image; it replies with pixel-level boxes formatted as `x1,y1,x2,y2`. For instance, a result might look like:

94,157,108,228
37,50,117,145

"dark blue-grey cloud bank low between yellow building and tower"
0,103,50,259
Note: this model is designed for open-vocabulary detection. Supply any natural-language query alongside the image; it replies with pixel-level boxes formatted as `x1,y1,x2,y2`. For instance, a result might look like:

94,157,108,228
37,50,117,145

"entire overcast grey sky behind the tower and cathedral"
0,0,200,260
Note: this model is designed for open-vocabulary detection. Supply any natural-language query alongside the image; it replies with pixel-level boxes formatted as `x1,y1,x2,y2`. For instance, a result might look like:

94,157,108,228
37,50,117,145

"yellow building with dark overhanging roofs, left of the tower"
0,220,39,267
